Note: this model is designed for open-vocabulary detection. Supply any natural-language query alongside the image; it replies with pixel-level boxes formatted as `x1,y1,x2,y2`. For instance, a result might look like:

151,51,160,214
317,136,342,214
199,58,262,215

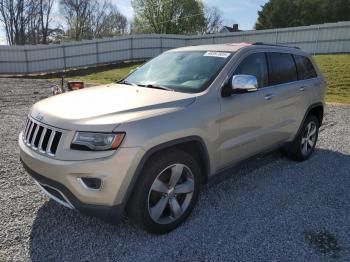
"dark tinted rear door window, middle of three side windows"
269,53,298,85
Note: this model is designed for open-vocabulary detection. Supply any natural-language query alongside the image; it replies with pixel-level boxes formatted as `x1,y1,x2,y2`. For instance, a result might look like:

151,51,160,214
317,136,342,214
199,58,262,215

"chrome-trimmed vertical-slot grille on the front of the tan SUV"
23,118,62,156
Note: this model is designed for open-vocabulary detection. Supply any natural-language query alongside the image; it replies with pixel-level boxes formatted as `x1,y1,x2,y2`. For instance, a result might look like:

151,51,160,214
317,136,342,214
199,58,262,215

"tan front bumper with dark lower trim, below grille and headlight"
19,134,144,220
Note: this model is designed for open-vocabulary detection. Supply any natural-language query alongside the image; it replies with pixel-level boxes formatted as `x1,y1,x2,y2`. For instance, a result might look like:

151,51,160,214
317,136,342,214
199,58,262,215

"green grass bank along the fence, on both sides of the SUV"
12,54,350,104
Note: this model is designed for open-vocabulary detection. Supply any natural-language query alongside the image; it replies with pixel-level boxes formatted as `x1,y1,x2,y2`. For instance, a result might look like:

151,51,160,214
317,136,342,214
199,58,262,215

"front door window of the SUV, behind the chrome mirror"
234,53,268,87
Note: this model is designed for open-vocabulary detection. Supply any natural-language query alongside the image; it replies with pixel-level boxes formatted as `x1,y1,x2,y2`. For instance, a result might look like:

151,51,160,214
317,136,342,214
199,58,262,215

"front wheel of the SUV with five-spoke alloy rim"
127,149,201,234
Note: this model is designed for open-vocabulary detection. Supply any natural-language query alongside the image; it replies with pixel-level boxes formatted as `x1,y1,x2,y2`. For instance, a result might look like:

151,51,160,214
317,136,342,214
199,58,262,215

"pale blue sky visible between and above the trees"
0,0,268,45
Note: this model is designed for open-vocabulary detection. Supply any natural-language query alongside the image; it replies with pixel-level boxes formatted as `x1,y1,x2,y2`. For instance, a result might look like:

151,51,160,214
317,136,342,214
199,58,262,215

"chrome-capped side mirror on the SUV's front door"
224,75,258,96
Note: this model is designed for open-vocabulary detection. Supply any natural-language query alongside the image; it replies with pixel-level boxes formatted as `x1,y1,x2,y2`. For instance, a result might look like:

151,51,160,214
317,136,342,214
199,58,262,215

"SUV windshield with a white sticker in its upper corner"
124,51,231,93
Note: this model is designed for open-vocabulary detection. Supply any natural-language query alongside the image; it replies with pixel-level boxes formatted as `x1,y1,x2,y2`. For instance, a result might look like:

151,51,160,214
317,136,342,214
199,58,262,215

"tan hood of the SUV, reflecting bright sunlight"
30,84,195,131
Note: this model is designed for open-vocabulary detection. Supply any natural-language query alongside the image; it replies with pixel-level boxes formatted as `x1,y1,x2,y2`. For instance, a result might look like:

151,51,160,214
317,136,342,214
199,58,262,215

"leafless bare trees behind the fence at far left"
0,0,127,45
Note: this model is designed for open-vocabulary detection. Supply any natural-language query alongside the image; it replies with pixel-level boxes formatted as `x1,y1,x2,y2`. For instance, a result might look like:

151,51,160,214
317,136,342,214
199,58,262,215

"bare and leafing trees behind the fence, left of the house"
0,0,222,45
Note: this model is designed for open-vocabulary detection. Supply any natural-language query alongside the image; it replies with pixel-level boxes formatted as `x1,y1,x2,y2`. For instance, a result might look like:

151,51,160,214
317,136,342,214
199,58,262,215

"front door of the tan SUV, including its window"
218,53,272,168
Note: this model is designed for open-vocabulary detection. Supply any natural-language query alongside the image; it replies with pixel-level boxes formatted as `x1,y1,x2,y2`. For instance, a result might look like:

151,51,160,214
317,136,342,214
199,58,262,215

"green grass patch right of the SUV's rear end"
315,54,350,104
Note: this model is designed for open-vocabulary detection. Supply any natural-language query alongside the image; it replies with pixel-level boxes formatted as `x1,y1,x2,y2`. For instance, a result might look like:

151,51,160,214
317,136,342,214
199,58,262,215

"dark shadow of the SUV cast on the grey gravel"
29,149,350,261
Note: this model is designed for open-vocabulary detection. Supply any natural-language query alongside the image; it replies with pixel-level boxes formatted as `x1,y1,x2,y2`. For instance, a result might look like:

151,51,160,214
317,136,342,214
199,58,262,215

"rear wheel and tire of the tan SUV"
282,115,320,161
